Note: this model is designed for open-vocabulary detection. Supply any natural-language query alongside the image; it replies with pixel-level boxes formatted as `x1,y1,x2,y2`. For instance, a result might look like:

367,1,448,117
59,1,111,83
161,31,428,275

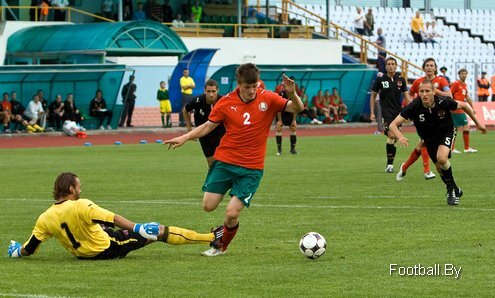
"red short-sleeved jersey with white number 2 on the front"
208,88,288,170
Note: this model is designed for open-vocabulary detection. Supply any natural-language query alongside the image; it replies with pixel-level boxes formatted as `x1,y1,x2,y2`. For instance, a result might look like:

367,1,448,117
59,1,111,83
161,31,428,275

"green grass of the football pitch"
0,133,495,297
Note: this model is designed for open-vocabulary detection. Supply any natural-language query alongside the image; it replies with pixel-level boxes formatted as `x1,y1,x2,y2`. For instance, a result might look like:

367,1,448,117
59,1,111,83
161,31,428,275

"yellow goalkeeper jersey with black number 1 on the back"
24,199,115,257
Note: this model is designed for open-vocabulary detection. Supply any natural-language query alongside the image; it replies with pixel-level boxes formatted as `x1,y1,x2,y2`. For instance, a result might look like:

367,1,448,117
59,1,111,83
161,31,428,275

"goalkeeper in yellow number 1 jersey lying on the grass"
8,173,222,259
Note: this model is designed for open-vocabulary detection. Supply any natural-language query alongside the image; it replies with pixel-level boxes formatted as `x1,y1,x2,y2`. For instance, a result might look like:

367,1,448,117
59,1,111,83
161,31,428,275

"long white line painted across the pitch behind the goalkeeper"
0,196,495,212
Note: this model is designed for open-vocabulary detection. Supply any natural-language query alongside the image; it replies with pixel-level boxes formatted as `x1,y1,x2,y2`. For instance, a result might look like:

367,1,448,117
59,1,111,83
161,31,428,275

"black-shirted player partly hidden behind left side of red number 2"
182,79,225,168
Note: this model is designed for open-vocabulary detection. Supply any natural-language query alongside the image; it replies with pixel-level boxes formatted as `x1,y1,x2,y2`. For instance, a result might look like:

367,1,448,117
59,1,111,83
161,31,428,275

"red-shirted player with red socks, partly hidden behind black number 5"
396,58,452,181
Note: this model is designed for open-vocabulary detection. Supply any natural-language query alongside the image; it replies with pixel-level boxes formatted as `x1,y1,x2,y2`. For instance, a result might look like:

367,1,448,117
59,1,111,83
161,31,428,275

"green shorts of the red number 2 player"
203,160,263,207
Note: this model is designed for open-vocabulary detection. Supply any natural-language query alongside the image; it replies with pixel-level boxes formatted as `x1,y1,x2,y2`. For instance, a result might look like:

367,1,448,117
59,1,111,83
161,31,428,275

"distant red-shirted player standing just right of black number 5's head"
450,68,478,153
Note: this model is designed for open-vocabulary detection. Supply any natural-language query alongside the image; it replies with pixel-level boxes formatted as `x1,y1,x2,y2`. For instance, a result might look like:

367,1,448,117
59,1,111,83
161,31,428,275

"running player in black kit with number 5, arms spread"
389,80,486,205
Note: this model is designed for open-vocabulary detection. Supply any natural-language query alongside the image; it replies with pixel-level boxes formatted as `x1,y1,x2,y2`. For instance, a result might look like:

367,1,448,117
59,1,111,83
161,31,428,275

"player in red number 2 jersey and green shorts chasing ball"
164,63,304,257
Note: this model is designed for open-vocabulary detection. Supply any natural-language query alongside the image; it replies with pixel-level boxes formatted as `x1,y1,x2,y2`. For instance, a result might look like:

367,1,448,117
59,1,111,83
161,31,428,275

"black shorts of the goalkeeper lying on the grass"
81,227,148,260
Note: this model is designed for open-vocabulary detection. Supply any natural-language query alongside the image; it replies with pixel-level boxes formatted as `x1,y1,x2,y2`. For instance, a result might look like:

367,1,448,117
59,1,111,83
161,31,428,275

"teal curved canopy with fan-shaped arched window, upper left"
7,21,188,59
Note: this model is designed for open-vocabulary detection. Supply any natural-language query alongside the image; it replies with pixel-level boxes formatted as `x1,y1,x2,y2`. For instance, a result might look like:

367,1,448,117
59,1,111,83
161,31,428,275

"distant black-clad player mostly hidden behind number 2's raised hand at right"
275,73,301,155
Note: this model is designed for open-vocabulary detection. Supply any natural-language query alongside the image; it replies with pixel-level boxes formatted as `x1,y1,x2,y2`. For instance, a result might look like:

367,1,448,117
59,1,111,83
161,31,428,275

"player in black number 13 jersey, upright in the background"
370,57,411,173
